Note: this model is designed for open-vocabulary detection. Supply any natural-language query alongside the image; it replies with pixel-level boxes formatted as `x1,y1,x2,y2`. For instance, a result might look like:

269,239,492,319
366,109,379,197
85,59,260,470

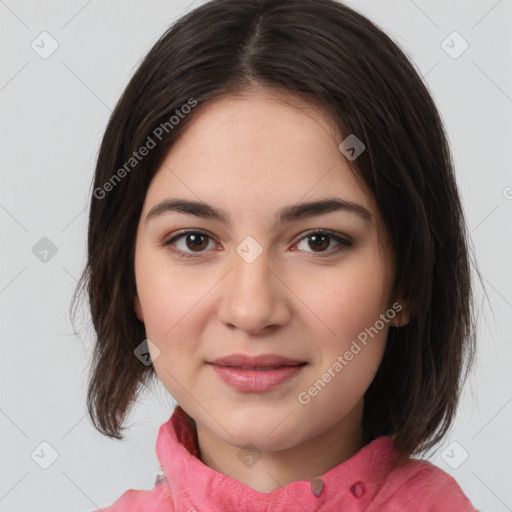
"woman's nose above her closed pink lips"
219,244,291,335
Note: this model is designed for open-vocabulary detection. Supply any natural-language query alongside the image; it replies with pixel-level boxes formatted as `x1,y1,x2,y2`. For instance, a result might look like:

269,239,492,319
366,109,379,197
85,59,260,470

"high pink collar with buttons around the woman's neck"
156,406,396,512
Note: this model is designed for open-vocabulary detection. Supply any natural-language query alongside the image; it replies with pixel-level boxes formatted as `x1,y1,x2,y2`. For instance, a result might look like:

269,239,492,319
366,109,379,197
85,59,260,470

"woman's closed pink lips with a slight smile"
208,354,308,393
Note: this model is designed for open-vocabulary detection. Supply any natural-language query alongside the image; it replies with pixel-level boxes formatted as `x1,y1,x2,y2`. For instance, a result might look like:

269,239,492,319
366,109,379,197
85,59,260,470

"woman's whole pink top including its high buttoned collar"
95,406,478,512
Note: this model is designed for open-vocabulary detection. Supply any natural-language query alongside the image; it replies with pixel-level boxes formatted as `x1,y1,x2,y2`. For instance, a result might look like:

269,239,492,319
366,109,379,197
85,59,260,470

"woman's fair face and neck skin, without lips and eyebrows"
134,88,408,493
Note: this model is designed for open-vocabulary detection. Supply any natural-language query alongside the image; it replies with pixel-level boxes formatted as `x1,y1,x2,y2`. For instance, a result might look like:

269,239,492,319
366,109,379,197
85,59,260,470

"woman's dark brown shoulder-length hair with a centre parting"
72,0,475,463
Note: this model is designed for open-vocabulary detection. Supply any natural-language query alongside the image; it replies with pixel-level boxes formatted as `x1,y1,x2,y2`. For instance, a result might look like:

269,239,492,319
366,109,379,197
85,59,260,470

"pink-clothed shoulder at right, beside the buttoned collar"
368,460,479,512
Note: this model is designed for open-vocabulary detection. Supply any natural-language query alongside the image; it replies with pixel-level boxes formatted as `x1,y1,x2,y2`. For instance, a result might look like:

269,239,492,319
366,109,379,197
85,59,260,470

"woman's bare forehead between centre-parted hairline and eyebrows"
152,89,364,191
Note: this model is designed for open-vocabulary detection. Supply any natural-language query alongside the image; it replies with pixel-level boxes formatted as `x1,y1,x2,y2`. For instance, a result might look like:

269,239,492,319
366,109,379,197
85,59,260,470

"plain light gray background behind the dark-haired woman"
0,0,512,512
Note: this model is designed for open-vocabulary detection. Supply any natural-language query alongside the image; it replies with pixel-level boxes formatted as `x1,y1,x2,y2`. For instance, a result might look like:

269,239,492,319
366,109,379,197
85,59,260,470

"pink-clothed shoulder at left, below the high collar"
90,482,174,512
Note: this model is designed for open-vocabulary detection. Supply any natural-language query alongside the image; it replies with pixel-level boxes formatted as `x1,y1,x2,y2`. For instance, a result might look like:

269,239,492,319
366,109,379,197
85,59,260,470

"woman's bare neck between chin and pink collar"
197,401,363,493
